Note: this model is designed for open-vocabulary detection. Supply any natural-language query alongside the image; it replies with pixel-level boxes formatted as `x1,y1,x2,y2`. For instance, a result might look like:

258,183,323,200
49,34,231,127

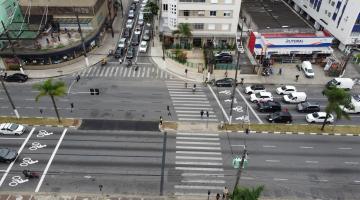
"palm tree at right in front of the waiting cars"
321,86,352,131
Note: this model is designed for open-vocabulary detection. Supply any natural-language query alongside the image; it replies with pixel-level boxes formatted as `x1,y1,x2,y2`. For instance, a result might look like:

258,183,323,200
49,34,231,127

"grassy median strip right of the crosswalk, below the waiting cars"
220,124,360,135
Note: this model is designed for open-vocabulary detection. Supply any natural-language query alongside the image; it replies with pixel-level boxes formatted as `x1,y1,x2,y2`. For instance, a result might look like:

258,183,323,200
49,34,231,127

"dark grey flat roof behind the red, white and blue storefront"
242,0,312,32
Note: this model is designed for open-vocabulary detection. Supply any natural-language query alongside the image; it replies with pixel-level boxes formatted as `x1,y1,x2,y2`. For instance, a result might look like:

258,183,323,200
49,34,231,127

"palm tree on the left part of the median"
33,79,66,123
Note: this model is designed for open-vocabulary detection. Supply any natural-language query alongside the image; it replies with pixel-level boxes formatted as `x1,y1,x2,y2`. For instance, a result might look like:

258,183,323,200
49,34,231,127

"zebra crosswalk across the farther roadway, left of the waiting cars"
166,80,218,122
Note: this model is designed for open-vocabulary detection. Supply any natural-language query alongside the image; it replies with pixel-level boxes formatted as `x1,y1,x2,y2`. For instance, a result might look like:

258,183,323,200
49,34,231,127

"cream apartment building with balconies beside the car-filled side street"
160,0,241,46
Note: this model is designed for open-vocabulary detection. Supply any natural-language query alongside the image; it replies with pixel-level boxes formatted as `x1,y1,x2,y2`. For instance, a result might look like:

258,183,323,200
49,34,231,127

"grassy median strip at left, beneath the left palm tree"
0,117,81,126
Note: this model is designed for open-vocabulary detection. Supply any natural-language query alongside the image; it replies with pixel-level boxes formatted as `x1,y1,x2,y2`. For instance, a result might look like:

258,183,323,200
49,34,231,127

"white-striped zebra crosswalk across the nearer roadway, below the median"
174,132,226,196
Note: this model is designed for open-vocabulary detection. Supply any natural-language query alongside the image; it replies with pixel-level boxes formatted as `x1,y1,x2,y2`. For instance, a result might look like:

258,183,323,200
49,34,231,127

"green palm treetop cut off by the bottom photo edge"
230,185,265,200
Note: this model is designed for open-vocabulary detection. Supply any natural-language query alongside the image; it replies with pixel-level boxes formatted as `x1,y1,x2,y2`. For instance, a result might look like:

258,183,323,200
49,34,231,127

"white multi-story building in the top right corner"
287,0,360,50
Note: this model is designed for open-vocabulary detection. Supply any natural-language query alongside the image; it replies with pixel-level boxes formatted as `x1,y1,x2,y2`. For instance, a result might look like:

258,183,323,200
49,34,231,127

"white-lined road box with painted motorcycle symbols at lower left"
0,127,67,192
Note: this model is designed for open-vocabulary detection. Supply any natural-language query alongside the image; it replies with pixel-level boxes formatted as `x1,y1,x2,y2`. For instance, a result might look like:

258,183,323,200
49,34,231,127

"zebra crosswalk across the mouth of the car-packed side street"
72,64,173,80
